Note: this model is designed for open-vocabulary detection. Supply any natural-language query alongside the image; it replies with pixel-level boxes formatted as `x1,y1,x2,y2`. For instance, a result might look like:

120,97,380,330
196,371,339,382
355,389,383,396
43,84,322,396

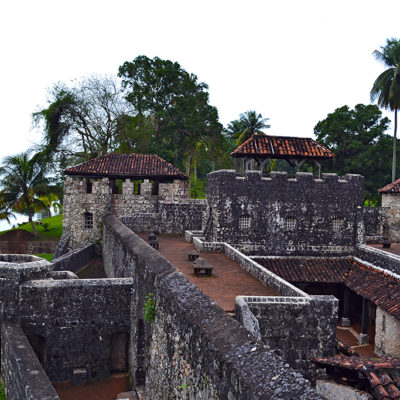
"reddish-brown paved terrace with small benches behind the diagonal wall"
138,234,279,313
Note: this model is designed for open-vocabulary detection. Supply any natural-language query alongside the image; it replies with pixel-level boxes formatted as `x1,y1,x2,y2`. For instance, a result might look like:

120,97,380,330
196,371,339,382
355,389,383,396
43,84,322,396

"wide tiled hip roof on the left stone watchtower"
64,153,188,179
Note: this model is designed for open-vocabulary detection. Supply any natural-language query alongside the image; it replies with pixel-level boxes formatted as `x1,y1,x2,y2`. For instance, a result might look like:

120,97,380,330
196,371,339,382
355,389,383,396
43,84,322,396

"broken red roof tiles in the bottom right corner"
313,355,400,400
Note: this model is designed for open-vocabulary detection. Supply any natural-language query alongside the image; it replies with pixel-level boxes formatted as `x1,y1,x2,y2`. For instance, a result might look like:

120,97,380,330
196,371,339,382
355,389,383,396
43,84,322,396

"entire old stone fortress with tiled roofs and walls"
0,135,400,400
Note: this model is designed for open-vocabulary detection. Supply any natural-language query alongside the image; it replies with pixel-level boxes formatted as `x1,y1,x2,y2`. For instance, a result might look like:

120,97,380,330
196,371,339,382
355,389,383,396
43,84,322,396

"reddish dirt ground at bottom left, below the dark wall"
53,374,130,400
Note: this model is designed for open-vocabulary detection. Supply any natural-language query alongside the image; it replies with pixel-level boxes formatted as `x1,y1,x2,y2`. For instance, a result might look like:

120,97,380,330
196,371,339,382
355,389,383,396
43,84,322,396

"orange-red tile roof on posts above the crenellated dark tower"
231,135,334,159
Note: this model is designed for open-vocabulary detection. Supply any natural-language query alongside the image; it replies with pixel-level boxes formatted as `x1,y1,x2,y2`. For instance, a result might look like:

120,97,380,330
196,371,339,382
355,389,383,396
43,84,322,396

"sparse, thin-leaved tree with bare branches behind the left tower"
33,76,131,159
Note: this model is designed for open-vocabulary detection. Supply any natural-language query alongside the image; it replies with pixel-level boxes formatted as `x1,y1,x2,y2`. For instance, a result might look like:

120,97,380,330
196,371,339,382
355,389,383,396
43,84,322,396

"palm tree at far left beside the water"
0,152,49,236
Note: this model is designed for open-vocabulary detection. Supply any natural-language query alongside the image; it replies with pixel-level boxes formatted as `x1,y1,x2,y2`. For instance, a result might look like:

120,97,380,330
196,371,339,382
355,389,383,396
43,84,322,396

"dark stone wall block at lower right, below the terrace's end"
236,296,339,379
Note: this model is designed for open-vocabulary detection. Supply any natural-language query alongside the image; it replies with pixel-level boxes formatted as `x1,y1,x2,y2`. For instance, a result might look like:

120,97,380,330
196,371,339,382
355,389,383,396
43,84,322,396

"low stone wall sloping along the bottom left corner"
1,324,59,400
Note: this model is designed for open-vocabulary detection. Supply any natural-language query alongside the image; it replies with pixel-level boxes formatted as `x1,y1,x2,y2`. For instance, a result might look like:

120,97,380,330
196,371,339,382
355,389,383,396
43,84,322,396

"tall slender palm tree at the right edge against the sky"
370,38,400,182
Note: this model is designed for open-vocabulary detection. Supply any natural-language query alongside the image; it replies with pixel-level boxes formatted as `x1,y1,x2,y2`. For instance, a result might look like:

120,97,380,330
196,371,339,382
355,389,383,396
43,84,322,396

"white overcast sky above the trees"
0,0,400,159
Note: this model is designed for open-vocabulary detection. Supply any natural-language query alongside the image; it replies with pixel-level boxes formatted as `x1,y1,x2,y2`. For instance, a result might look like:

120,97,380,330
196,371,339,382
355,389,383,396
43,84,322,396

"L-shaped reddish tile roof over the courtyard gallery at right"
253,257,400,319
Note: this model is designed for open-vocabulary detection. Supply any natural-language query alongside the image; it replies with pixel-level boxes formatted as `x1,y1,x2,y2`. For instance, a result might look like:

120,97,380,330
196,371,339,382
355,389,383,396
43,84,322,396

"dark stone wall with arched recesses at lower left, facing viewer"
19,279,132,381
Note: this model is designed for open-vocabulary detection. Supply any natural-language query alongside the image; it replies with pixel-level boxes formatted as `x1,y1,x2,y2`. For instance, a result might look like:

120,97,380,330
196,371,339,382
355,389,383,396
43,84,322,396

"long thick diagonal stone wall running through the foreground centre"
103,216,319,400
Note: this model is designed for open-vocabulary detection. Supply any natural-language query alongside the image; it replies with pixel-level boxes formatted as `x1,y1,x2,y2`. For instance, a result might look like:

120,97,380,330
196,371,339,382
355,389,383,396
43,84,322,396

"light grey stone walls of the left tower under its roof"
63,176,206,248
